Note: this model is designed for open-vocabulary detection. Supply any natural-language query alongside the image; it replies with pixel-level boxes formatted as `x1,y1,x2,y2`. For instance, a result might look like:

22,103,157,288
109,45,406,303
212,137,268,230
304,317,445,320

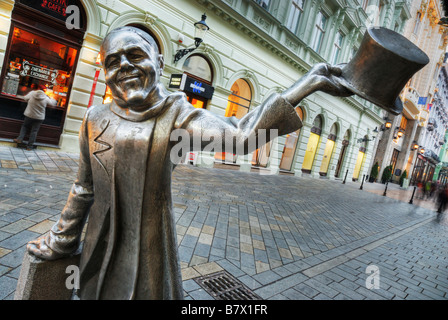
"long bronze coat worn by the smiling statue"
47,88,302,299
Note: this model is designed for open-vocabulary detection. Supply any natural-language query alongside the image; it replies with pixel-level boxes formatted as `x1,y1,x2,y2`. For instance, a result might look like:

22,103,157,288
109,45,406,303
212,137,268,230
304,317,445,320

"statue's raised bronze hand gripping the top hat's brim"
308,63,353,97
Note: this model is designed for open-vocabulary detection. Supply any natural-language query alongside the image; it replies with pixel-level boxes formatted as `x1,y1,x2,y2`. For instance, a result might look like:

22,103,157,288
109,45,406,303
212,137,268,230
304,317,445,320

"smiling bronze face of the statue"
101,31,163,109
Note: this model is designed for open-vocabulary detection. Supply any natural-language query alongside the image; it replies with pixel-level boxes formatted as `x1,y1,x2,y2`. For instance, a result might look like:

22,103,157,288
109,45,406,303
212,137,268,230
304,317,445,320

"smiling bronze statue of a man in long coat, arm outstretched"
28,27,428,299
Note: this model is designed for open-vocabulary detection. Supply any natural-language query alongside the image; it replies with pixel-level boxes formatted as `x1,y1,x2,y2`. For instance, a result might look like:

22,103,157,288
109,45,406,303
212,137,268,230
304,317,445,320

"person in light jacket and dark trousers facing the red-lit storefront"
14,85,57,151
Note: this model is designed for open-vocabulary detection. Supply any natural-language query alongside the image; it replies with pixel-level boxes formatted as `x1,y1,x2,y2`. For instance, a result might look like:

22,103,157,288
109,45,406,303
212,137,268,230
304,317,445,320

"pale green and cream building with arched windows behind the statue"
0,0,412,180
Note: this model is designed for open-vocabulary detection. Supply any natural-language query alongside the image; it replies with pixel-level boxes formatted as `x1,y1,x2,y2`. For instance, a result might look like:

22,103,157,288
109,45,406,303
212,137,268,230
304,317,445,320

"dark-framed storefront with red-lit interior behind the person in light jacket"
0,0,86,145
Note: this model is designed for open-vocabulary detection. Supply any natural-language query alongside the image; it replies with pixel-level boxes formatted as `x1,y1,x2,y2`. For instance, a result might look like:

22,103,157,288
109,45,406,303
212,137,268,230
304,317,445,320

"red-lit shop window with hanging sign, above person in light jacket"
1,27,78,108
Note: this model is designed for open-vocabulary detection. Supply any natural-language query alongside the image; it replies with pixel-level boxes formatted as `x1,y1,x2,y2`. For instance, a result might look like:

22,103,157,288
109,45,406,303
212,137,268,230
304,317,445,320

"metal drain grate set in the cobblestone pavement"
194,271,262,300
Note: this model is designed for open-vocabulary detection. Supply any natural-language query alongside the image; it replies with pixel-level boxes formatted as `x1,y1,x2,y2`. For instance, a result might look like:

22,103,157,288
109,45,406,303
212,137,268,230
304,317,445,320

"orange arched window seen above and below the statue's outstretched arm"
215,79,252,163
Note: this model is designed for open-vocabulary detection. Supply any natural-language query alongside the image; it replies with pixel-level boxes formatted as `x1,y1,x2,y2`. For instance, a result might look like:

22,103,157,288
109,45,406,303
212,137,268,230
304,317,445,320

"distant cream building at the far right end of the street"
374,0,448,184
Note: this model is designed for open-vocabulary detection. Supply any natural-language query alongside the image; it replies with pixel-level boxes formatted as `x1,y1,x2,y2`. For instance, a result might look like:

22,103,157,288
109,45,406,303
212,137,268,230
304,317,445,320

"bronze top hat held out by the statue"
342,27,429,115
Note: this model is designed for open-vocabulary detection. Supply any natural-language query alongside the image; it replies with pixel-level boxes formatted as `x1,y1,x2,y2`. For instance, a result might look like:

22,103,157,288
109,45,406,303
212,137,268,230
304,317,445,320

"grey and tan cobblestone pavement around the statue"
0,147,448,300
